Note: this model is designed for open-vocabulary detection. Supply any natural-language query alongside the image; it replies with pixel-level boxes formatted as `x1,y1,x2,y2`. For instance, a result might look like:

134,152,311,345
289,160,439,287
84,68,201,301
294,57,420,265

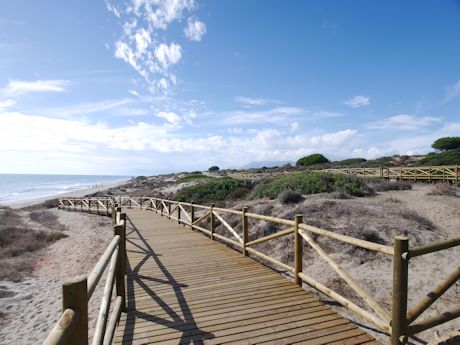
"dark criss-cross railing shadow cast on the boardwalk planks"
123,217,214,344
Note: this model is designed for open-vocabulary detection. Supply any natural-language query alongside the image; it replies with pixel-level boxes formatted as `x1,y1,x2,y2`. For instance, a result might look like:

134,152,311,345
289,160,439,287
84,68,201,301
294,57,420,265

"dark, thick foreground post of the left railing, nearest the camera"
62,276,88,345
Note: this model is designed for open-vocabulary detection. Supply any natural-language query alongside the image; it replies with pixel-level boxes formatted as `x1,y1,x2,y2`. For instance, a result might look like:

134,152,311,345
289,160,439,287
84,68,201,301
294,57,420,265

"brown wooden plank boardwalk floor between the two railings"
114,209,379,345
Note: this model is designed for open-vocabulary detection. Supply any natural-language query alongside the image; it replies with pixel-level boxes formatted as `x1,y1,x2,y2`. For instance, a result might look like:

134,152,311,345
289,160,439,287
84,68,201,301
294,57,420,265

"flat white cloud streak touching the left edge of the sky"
0,80,69,97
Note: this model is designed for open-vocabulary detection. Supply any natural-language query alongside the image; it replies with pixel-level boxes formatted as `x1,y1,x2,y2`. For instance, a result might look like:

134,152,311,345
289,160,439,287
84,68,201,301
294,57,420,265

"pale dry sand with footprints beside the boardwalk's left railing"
0,210,113,345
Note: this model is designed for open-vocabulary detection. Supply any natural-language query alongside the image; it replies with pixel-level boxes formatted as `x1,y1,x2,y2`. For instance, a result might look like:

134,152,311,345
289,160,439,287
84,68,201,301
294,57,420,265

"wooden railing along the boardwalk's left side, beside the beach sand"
43,202,126,345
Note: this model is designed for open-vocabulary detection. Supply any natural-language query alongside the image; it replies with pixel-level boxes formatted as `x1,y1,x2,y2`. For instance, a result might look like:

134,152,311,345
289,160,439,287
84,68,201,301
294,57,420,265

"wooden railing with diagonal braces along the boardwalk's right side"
54,196,460,345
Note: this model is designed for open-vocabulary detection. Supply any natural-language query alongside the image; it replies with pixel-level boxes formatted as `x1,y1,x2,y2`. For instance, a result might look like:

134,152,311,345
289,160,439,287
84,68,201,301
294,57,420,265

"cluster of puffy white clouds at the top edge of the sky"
106,0,206,94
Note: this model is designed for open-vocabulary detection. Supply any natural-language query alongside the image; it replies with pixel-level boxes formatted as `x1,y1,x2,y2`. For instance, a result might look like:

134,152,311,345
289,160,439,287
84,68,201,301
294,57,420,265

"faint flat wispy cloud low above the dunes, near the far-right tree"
367,114,441,131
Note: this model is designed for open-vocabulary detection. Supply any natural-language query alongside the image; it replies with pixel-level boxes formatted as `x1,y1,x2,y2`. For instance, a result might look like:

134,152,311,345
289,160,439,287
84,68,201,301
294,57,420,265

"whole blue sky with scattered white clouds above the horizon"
0,0,460,175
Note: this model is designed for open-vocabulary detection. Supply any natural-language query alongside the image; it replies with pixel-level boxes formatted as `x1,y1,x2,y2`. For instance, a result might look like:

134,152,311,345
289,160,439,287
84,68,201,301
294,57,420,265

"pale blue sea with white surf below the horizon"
0,174,131,205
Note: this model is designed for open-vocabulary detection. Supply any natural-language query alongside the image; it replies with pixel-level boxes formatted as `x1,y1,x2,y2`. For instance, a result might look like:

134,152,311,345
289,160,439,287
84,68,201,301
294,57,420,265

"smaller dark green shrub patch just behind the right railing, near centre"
174,178,249,203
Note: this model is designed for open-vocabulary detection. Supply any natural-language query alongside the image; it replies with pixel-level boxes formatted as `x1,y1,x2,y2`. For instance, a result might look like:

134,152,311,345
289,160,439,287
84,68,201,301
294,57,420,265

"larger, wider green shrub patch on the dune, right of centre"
252,172,373,199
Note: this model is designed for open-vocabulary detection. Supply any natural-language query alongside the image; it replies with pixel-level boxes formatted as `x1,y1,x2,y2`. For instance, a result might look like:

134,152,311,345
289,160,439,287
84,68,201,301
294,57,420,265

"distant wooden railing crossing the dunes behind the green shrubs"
228,165,460,182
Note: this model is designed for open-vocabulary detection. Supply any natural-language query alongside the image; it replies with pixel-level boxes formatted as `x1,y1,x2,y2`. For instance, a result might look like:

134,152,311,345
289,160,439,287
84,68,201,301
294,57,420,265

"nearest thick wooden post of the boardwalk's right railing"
391,236,409,345
